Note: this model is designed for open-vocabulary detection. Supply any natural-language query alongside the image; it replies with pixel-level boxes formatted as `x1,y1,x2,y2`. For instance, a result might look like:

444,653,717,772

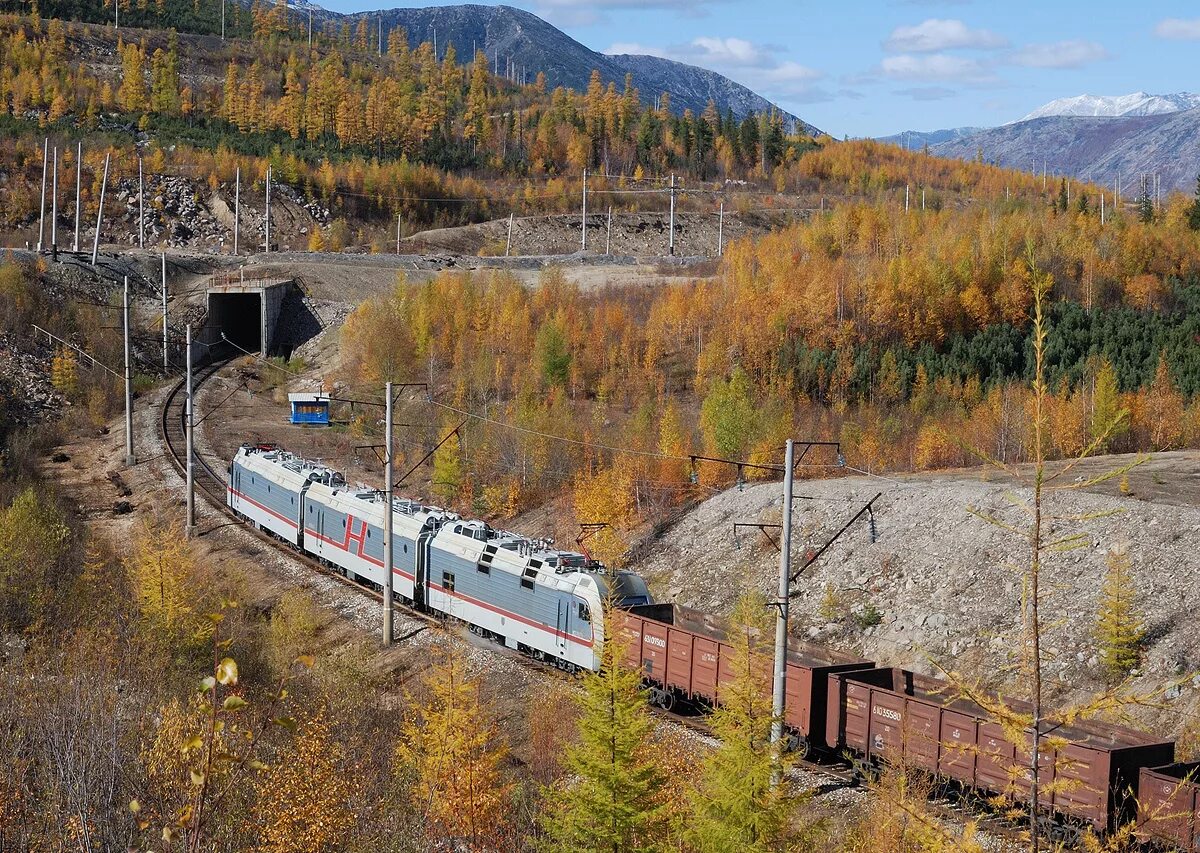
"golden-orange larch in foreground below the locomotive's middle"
397,648,511,851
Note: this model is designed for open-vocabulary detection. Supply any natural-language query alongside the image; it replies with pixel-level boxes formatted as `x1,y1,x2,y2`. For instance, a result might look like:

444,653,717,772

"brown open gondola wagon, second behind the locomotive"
826,668,1175,835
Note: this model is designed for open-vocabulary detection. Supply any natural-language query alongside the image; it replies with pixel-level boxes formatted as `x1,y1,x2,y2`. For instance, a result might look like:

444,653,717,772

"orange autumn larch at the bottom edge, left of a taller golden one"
253,708,354,853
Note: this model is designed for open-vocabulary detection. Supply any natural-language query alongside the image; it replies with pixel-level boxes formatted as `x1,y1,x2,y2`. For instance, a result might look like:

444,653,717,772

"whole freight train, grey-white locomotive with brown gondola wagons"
228,444,1200,852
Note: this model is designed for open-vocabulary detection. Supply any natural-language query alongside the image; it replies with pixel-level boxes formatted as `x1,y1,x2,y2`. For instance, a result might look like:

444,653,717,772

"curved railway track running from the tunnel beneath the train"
160,355,1020,841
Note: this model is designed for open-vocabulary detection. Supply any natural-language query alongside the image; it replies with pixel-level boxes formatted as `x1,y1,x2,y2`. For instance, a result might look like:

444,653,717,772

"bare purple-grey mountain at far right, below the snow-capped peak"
931,108,1200,198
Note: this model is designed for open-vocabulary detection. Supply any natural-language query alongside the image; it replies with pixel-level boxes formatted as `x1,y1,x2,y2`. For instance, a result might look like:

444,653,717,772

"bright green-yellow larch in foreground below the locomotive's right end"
539,614,662,853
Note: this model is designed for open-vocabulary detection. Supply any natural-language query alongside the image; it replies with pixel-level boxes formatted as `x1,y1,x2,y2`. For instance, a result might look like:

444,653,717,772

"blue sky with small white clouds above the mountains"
318,0,1200,137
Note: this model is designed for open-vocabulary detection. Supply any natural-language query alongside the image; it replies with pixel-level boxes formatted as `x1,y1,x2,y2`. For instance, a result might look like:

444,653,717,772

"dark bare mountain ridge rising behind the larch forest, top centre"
343,4,816,126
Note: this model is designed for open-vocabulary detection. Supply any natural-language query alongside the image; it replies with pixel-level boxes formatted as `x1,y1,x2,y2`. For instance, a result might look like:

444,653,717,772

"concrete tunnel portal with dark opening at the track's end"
200,278,294,356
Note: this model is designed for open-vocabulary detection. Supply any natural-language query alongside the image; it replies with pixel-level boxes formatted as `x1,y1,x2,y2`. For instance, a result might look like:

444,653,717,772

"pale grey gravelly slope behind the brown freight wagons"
637,452,1200,728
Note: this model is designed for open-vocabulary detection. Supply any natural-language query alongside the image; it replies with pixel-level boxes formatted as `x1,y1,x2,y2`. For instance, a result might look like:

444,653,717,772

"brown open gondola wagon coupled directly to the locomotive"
614,603,875,751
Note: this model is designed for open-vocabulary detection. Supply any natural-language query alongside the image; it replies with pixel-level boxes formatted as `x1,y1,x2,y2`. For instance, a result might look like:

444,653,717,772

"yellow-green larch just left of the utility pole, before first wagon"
685,594,794,853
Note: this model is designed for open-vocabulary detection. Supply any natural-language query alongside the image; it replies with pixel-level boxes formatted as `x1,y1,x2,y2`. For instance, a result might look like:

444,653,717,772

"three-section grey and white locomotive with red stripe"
227,444,652,669
